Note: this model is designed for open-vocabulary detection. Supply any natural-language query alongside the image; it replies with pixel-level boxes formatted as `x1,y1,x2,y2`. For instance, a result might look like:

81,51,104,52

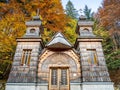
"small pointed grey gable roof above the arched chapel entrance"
46,32,72,49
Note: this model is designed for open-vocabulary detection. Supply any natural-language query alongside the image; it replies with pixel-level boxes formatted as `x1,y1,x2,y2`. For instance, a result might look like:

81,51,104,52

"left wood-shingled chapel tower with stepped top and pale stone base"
6,16,44,90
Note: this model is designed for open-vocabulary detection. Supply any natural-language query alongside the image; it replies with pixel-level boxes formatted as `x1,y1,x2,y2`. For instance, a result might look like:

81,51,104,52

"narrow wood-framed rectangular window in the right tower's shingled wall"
87,49,98,65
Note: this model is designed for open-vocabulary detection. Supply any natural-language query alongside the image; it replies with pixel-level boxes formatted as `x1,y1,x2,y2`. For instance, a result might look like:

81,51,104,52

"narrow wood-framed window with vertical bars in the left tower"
21,49,32,66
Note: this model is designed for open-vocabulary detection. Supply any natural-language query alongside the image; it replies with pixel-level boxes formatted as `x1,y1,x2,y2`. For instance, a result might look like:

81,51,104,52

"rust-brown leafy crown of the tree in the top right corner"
98,0,120,30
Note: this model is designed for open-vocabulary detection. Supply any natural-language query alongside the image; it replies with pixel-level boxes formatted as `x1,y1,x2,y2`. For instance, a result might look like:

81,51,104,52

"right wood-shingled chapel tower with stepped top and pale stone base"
75,15,113,90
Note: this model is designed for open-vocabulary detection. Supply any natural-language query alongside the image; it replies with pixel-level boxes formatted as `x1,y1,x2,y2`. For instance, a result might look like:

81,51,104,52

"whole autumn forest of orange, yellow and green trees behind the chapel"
0,0,120,90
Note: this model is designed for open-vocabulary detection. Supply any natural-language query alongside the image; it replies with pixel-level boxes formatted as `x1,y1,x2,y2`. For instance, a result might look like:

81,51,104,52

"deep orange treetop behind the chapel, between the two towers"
40,0,66,31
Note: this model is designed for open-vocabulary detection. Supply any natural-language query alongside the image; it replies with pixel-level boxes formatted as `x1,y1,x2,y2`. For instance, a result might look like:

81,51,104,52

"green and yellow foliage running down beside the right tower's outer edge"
94,21,120,70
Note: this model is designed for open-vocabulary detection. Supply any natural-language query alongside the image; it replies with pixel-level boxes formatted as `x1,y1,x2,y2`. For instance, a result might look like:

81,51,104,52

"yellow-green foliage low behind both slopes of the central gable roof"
42,18,77,44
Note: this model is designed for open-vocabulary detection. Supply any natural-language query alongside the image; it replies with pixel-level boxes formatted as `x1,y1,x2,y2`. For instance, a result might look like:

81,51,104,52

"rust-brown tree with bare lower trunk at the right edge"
98,0,120,50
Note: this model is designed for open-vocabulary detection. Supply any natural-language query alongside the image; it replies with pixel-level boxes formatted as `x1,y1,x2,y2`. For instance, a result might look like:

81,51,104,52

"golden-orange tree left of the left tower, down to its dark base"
0,2,25,79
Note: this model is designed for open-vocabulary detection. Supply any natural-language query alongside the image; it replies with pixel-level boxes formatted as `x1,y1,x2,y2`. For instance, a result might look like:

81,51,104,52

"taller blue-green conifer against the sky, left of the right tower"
66,0,79,19
